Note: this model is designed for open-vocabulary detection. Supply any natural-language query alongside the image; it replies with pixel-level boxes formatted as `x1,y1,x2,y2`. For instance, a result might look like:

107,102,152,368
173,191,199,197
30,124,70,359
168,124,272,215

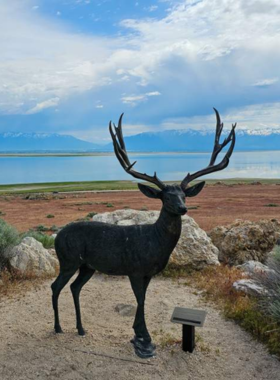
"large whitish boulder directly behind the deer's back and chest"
92,209,219,269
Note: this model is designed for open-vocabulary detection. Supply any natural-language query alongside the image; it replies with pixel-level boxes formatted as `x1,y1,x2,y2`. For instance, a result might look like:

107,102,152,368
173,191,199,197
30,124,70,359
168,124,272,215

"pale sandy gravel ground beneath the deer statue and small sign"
0,275,280,380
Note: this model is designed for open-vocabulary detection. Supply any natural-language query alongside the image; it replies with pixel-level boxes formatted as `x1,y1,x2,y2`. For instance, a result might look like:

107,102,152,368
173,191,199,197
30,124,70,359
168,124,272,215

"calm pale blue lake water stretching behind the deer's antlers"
0,151,280,184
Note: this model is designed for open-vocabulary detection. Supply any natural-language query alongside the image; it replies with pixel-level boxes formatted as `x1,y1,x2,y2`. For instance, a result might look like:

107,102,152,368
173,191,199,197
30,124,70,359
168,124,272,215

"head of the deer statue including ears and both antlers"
109,108,236,215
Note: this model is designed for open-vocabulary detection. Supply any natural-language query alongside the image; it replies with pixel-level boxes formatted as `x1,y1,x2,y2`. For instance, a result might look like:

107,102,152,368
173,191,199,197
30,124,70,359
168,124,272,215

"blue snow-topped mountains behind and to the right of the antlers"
104,129,280,152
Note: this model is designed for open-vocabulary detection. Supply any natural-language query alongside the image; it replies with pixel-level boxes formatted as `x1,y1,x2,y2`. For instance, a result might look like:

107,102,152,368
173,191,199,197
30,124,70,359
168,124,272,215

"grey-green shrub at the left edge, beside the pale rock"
0,219,20,270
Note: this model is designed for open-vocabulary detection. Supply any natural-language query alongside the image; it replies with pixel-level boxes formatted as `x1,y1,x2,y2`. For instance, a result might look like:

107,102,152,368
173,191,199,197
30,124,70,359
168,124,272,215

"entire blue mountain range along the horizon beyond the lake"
0,129,280,152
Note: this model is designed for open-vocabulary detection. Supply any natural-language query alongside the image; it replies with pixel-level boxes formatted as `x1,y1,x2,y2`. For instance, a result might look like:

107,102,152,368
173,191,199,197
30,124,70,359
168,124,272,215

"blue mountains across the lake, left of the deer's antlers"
0,132,100,152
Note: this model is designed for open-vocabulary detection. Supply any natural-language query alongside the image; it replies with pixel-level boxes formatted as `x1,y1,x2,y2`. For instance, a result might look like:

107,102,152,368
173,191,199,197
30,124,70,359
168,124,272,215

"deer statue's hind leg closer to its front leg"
70,265,95,336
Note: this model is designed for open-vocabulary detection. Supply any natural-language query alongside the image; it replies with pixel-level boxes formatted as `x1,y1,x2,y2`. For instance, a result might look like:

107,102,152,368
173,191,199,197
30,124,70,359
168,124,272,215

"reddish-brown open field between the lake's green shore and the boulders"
0,184,280,231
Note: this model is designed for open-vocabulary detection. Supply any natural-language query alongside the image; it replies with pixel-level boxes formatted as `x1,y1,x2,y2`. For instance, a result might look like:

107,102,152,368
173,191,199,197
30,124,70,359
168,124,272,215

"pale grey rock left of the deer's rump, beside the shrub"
8,237,58,276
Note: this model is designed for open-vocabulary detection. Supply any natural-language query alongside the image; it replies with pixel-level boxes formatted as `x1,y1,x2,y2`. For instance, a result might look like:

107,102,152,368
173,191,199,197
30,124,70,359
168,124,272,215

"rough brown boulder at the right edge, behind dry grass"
209,219,280,265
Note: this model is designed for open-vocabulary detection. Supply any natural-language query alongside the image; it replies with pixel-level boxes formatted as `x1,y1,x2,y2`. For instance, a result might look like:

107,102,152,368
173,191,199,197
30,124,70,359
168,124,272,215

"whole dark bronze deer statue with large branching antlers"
51,109,236,358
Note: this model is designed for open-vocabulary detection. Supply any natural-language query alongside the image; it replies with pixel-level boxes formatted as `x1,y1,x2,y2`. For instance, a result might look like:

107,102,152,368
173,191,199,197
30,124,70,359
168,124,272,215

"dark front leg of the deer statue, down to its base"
129,276,156,358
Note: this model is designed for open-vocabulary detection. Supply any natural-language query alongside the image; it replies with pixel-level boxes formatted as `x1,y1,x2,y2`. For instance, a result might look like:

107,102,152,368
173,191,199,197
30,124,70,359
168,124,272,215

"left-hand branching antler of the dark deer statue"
109,113,165,189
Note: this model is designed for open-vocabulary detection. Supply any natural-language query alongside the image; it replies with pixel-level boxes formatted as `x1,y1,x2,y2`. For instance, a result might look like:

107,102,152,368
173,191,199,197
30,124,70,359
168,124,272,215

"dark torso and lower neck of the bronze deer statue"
55,210,181,276
